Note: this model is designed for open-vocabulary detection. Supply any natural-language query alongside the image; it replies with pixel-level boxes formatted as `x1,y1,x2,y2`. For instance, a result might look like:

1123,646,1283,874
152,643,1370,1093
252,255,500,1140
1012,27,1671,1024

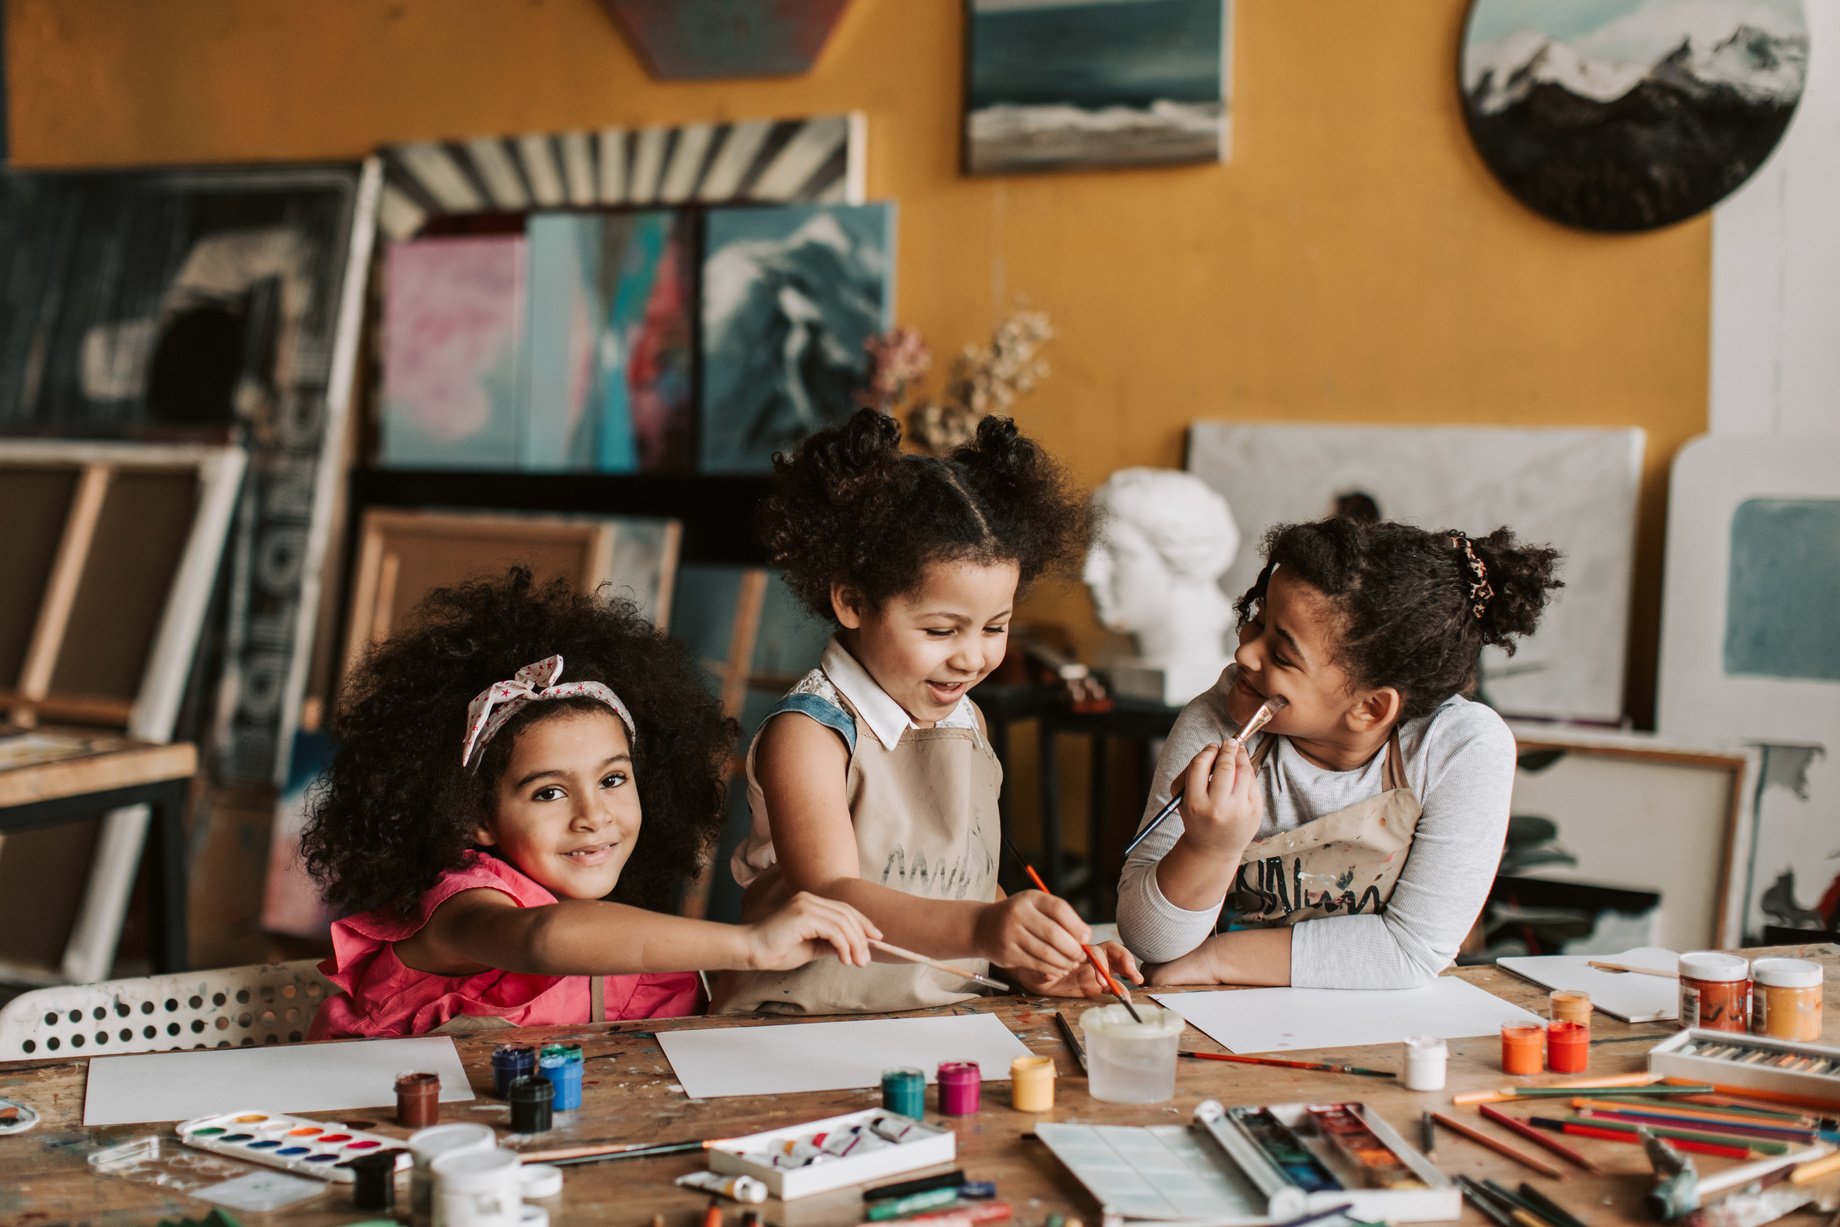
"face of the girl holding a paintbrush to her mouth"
1227,567,1397,765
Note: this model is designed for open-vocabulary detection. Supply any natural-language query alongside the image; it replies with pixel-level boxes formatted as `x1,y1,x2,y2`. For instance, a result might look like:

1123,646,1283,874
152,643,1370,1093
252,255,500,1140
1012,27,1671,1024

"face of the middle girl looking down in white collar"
832,561,1021,728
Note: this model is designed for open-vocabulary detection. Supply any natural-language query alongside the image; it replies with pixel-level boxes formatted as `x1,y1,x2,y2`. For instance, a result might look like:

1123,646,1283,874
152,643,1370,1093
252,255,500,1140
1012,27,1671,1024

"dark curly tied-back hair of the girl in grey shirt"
1235,515,1564,719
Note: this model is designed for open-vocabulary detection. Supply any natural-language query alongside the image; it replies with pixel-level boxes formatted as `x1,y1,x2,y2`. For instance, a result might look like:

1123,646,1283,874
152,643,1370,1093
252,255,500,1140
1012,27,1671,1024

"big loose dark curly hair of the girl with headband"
300,567,736,916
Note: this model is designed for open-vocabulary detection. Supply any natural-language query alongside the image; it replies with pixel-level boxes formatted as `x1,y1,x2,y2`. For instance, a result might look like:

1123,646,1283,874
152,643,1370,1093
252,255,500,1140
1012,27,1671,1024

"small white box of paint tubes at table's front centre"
708,1107,959,1201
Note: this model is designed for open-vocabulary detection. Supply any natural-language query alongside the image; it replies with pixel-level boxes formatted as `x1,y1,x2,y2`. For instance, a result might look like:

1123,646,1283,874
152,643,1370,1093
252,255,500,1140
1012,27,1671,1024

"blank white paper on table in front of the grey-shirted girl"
1152,975,1542,1052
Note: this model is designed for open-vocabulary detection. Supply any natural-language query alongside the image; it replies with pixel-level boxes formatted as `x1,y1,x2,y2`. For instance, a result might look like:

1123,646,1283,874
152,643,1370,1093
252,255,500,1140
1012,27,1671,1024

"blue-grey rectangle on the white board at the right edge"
1724,499,1840,682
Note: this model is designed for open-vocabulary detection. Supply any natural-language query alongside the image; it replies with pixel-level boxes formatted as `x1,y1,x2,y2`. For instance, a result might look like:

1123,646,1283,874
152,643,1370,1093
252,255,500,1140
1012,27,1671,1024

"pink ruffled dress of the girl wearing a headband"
307,852,705,1039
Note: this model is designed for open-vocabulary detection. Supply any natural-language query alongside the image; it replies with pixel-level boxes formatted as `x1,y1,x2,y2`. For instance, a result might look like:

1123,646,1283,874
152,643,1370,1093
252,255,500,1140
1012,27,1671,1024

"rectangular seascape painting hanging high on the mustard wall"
964,0,1231,175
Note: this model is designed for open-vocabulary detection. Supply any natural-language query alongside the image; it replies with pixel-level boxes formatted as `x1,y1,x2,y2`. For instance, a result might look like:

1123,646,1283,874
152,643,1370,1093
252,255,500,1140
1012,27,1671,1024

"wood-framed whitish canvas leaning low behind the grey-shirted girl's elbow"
1511,723,1757,951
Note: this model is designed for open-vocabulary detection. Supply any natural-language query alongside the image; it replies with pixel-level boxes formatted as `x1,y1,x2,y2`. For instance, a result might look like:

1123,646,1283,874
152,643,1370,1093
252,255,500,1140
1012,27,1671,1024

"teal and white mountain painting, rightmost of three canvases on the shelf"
701,204,894,473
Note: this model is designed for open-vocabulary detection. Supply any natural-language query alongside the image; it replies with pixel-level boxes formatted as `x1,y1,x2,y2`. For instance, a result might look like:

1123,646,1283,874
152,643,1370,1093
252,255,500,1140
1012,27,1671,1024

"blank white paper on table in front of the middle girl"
659,1014,1029,1100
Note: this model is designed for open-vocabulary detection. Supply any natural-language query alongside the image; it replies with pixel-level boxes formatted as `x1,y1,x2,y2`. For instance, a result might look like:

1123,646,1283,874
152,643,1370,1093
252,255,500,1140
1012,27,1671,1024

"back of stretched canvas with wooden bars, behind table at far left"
0,440,247,984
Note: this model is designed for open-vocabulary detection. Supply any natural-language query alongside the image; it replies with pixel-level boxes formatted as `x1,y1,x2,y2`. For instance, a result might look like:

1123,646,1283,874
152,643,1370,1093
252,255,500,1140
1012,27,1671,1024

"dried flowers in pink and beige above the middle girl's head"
859,307,1054,456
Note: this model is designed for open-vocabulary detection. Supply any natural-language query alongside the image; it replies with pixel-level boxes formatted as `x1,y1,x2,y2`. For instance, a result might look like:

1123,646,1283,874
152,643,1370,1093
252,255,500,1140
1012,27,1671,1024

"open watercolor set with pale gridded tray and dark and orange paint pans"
1036,1100,1463,1227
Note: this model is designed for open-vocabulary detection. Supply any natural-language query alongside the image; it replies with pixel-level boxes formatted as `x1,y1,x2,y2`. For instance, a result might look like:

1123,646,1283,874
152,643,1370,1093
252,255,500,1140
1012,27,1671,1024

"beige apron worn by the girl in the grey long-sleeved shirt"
1220,730,1422,925
